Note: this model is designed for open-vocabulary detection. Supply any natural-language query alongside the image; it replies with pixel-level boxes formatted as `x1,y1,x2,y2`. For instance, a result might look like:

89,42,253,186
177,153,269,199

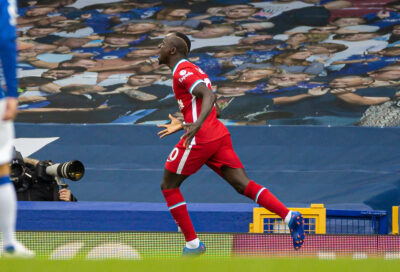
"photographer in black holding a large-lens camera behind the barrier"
11,150,77,201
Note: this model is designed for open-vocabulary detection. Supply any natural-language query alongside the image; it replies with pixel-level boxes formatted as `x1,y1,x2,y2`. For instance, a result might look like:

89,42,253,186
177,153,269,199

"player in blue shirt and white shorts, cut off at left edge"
0,0,34,258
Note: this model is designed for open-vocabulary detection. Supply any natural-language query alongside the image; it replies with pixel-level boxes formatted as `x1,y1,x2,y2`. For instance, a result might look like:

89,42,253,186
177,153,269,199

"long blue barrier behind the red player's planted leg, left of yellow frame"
17,201,255,232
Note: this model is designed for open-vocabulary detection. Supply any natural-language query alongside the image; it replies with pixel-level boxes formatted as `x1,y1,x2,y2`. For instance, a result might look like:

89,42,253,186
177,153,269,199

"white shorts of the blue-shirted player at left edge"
0,99,14,165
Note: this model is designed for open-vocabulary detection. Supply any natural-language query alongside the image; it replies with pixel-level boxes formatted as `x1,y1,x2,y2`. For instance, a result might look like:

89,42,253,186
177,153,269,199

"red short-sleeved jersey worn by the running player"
172,59,229,143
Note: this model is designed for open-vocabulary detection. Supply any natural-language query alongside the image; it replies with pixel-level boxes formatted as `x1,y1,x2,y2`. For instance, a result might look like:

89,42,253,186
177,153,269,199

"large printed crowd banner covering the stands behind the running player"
16,0,400,127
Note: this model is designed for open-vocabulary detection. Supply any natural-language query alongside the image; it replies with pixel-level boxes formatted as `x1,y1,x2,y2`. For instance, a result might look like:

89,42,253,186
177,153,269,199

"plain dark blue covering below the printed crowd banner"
16,124,400,210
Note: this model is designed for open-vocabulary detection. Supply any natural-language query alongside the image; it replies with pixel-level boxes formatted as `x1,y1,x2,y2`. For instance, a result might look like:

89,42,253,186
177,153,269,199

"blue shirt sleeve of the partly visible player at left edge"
0,0,18,97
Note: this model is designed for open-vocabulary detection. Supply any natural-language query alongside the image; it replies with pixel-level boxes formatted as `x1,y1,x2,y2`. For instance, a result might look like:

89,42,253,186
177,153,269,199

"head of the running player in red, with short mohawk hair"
158,32,191,64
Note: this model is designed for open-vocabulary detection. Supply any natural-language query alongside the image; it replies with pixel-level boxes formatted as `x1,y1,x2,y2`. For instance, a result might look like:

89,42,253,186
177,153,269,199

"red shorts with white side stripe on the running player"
165,135,243,176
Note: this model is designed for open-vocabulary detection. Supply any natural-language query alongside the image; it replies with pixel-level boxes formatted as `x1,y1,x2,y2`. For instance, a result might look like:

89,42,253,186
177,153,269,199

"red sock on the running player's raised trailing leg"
243,180,289,219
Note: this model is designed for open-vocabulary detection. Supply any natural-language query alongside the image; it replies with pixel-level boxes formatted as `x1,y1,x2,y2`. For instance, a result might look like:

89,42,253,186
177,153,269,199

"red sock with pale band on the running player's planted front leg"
162,188,197,242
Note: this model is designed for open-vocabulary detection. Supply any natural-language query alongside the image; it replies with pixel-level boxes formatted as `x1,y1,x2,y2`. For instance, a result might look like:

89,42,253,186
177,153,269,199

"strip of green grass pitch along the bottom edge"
0,258,400,272
